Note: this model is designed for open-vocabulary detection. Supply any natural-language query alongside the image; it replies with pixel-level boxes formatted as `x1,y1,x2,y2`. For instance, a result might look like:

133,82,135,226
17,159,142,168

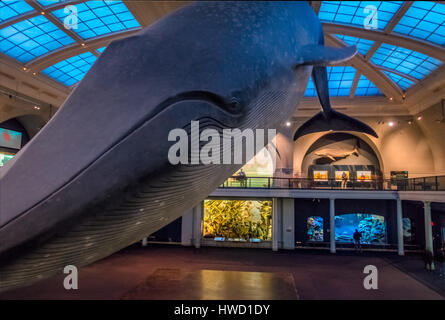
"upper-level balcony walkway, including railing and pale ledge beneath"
210,176,445,202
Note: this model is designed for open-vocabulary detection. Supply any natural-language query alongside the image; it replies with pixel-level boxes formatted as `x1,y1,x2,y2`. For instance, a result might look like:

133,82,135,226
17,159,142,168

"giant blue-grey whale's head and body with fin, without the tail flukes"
0,2,356,291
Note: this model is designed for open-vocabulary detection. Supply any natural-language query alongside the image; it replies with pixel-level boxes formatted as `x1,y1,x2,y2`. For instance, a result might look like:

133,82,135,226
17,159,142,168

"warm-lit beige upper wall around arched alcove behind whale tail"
293,104,445,178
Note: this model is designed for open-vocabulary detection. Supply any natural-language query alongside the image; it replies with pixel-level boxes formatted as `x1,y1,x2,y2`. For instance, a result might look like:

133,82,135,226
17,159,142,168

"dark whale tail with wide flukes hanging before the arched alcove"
294,67,378,140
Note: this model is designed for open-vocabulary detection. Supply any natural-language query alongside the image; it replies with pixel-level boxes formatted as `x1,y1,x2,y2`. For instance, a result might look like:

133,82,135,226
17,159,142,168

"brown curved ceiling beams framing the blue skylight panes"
0,0,445,114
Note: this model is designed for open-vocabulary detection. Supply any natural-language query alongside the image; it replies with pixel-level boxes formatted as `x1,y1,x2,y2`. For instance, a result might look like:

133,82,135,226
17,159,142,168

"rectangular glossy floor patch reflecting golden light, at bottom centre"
124,269,298,300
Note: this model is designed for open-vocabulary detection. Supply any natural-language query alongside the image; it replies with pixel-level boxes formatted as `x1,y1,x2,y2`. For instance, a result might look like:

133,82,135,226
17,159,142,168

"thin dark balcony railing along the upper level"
220,176,445,191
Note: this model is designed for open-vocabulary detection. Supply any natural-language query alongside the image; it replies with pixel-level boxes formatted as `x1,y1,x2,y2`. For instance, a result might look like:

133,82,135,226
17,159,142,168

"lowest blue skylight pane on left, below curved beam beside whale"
42,52,97,86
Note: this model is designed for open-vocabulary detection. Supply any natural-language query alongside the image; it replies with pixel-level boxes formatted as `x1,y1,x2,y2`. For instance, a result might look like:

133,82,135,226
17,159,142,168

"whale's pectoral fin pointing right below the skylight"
298,44,357,66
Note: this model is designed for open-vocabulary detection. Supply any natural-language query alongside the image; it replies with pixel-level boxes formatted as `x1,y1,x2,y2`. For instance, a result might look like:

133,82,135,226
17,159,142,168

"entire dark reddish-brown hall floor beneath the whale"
0,246,445,300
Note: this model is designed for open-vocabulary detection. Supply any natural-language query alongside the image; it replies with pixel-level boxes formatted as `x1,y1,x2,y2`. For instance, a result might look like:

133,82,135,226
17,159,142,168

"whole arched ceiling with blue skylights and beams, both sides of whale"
0,0,445,117
